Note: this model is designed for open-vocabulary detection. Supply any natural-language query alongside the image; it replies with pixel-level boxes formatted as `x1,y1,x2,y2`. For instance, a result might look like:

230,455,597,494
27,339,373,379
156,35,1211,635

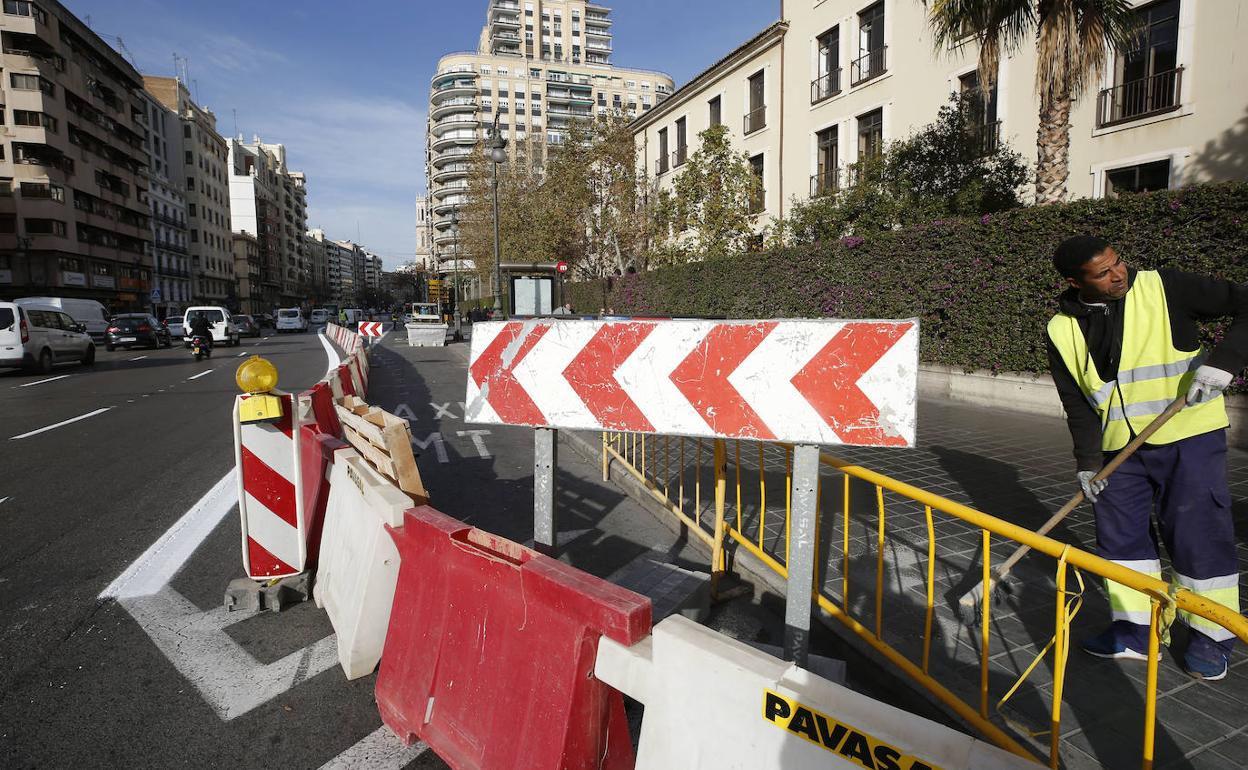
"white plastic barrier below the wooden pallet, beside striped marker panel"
313,449,413,679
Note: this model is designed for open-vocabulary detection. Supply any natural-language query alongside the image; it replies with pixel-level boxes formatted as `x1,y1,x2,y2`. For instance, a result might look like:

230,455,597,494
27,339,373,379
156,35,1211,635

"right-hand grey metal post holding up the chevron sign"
784,444,819,668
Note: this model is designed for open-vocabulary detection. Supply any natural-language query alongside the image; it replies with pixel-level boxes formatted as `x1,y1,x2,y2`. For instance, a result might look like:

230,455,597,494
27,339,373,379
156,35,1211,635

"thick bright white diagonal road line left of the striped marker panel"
100,470,238,599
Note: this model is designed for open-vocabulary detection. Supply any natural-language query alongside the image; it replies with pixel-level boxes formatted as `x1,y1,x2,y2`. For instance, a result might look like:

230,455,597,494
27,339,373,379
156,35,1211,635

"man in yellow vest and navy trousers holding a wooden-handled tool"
1048,236,1248,680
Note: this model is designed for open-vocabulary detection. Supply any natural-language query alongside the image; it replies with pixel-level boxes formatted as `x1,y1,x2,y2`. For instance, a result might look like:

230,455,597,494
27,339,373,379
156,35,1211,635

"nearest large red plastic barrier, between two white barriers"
377,505,650,770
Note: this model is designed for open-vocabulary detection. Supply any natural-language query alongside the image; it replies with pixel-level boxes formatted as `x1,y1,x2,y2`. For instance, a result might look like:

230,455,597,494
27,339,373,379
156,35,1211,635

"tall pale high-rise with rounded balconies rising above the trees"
426,0,673,265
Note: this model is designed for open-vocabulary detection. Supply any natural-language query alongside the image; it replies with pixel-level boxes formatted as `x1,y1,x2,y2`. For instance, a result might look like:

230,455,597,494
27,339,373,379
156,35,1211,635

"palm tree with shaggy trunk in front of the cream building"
930,0,1137,203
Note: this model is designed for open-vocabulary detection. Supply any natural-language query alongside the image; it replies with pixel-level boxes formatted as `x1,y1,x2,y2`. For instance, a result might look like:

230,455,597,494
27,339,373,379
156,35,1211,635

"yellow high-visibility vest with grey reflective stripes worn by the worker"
1048,270,1228,452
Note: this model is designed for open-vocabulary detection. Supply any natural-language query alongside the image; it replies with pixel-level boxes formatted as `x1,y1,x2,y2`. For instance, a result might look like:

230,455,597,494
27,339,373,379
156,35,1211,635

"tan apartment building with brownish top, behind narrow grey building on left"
144,75,238,307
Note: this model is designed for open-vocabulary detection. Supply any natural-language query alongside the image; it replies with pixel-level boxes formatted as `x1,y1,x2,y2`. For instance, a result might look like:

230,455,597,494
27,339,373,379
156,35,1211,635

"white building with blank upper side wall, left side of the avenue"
227,136,312,308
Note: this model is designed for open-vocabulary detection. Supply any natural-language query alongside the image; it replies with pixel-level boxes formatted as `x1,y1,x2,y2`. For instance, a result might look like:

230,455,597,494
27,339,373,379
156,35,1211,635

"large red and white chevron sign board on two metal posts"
466,319,919,447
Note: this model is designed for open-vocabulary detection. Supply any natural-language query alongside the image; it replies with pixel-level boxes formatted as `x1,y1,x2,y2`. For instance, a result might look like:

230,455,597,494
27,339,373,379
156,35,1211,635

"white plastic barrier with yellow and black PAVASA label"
594,615,1038,770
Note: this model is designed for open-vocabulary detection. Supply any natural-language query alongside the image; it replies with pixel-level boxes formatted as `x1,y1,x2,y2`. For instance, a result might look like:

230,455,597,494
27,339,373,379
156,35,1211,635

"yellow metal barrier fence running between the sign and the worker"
602,433,1248,770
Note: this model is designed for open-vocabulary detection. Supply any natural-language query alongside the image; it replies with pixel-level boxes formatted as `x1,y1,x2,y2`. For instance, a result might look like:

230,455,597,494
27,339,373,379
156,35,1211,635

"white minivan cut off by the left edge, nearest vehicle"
0,302,95,372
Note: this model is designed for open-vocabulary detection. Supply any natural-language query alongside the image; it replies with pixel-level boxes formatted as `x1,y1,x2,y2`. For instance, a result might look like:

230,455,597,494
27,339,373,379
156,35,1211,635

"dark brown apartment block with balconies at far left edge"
0,0,152,311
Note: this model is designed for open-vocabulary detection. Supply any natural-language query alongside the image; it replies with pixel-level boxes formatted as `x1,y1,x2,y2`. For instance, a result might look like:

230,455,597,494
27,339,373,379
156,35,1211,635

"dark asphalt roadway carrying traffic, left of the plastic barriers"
0,332,404,768
